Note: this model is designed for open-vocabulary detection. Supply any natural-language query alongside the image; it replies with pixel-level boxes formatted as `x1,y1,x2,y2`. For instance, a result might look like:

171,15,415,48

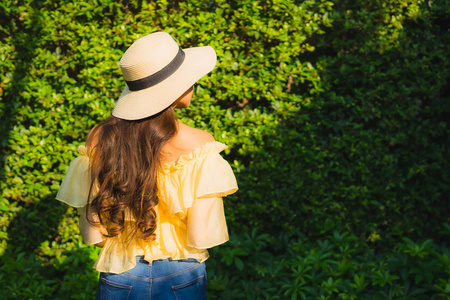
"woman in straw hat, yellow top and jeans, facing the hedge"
56,32,237,300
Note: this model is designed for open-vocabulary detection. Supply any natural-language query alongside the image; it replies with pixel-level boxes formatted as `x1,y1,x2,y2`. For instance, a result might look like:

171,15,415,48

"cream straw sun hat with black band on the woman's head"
112,32,216,120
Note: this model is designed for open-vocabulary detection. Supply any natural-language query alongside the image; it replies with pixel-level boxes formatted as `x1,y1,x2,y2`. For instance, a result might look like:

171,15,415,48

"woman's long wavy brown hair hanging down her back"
86,107,177,241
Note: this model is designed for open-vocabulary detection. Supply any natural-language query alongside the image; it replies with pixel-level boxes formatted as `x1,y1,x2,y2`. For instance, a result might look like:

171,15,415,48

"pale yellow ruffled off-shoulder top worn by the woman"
56,141,238,273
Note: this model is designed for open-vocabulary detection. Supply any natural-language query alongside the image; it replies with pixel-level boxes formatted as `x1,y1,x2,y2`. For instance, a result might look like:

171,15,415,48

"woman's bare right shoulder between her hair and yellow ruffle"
177,122,215,151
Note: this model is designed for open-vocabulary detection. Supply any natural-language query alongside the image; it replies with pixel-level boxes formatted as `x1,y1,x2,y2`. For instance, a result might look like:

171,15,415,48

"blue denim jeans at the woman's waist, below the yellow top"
96,256,207,300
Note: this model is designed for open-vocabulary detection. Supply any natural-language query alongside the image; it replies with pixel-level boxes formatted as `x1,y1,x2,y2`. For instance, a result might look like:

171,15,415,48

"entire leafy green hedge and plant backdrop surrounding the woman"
0,0,450,299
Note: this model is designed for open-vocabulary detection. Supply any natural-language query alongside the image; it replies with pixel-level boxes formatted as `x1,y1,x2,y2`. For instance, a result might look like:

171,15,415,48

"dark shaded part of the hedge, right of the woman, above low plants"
232,1,450,245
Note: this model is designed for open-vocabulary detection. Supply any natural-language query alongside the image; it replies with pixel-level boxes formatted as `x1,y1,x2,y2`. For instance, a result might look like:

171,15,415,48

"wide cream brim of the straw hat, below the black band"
112,46,217,120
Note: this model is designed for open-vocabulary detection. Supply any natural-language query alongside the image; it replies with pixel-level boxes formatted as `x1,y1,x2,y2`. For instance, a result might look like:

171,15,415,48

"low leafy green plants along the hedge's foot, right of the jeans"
207,230,450,299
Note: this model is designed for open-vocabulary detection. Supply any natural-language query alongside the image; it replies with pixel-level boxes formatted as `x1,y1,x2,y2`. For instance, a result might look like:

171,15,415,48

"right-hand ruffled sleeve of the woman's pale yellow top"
160,142,238,249
